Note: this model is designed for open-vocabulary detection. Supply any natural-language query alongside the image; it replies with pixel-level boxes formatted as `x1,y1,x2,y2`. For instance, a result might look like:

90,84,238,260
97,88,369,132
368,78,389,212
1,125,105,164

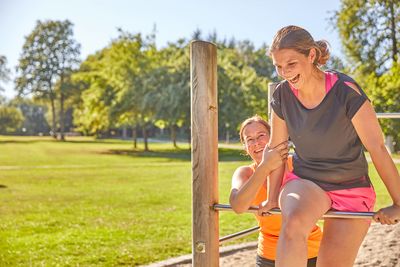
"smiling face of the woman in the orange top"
243,122,269,163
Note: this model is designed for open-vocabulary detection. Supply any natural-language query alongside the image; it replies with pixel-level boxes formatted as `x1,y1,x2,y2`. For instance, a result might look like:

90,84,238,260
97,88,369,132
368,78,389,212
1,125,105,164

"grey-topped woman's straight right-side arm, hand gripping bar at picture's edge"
351,101,400,224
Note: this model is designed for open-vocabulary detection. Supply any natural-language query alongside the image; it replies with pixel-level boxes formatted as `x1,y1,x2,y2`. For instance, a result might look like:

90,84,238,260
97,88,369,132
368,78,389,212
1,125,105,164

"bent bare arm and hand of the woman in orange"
229,140,288,213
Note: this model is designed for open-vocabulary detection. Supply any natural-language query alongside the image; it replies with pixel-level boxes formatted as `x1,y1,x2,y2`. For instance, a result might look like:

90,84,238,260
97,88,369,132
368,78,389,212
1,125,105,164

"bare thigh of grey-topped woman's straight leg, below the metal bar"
317,219,370,267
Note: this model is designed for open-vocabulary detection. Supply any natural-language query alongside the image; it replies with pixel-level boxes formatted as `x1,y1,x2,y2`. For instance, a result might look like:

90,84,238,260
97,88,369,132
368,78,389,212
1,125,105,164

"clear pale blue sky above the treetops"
0,0,343,98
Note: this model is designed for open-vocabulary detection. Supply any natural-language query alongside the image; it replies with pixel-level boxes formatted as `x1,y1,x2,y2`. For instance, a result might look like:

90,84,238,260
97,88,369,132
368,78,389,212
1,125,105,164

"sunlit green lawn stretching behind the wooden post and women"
0,137,396,266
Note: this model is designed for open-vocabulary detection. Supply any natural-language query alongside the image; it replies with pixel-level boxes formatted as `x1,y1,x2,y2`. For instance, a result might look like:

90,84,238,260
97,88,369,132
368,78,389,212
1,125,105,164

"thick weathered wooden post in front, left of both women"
190,41,219,267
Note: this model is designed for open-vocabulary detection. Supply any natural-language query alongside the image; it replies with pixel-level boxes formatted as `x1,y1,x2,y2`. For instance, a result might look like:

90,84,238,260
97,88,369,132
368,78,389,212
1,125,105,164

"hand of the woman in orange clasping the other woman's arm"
260,141,289,171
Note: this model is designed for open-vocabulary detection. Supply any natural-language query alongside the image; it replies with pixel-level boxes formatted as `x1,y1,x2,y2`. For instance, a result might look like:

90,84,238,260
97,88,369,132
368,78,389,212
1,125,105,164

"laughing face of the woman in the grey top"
272,49,315,89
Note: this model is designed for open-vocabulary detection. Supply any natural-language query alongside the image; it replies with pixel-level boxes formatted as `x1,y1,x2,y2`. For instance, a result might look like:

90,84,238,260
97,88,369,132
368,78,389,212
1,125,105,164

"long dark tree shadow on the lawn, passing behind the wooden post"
101,148,249,161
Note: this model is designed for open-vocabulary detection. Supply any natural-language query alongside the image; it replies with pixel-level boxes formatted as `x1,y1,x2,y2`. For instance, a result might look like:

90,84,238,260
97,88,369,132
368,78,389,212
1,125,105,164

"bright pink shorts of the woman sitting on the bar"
281,172,376,212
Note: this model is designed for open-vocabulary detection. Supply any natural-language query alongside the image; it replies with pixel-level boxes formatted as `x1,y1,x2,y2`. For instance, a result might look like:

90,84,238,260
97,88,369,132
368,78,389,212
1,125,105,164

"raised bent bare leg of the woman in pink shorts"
276,179,331,267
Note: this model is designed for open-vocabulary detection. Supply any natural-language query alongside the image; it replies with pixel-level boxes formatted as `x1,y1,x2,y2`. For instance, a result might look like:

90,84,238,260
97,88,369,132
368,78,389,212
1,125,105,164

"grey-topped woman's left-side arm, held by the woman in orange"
258,111,289,215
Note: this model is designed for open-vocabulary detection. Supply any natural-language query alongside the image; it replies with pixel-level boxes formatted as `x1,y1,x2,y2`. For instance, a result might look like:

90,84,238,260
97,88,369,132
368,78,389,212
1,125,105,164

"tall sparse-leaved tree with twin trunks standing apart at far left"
16,20,80,140
